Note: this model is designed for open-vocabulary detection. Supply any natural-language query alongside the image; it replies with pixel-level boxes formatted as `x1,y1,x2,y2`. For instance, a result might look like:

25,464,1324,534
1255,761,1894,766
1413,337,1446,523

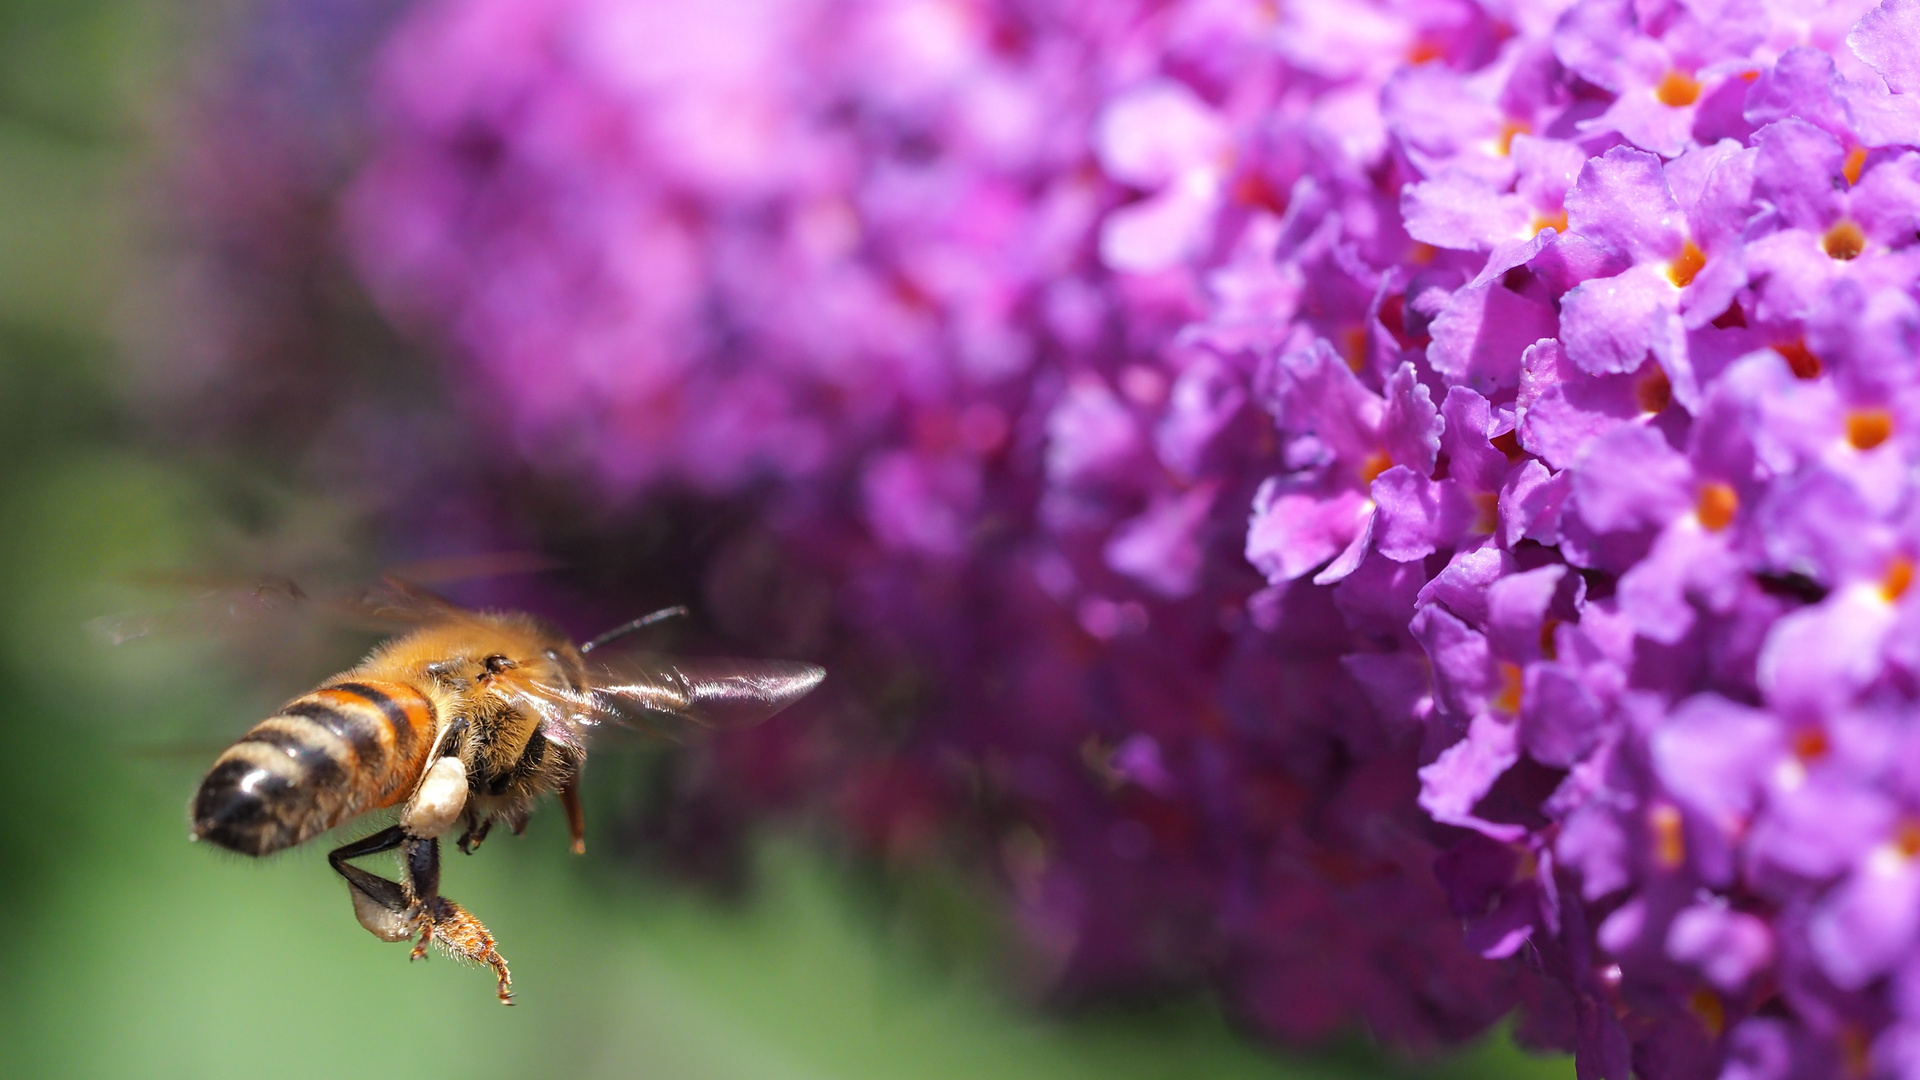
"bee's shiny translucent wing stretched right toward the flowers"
584,653,828,730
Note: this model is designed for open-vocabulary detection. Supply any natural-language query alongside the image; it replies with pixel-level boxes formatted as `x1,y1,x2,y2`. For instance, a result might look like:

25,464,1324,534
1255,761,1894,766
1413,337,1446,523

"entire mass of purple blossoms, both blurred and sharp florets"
210,0,1920,1080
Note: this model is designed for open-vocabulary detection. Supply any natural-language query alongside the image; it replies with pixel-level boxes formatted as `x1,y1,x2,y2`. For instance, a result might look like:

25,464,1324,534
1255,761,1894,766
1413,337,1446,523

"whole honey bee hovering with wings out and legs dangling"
192,580,826,1005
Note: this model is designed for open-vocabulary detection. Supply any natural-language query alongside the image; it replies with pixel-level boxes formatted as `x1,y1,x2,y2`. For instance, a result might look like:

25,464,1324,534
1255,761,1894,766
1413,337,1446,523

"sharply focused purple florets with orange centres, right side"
1228,0,1920,1080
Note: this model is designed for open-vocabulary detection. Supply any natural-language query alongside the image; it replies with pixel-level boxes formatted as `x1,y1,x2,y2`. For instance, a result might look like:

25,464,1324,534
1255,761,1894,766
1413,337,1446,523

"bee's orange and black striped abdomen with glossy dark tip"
194,680,434,855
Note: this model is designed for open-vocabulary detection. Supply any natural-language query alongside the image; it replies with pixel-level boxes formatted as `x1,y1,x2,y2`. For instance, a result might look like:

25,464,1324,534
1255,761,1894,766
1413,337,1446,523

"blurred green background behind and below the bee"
0,0,1572,1080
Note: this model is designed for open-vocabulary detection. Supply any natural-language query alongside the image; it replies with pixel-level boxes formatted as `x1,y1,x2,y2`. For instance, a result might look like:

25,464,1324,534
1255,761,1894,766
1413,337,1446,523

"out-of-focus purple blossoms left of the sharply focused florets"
346,0,1513,1045
